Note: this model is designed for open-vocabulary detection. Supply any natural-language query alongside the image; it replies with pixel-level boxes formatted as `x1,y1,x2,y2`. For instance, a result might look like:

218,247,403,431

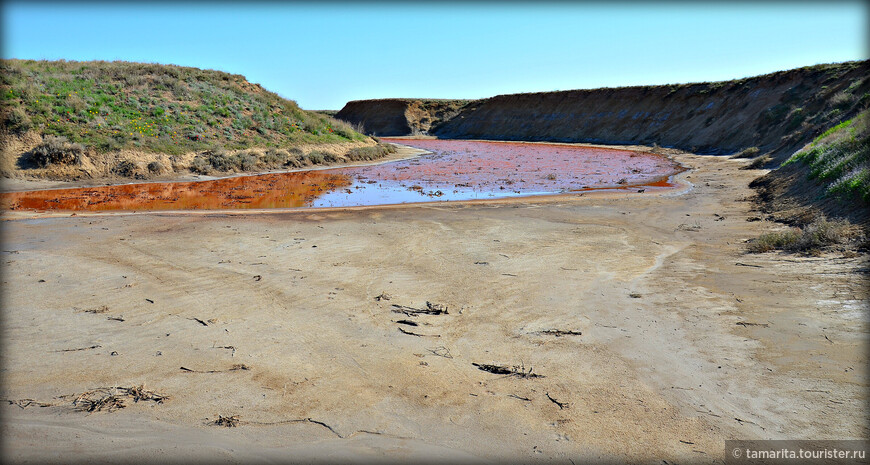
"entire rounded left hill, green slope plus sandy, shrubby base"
0,60,391,179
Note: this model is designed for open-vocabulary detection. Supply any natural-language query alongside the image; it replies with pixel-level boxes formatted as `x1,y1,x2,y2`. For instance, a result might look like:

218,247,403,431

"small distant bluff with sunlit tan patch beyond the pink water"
335,99,469,136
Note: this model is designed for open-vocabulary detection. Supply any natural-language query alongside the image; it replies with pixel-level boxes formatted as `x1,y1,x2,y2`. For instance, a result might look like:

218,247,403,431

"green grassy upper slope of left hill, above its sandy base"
0,60,365,154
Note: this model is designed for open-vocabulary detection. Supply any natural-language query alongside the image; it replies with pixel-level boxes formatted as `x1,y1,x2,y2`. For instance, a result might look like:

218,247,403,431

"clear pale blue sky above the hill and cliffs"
2,1,870,109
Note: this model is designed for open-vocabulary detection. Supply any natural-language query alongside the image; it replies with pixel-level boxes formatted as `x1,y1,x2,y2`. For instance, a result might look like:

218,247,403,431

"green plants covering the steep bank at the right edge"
783,110,870,201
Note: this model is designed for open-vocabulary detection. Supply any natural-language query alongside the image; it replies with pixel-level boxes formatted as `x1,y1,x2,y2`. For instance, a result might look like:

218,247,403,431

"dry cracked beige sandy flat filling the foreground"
0,150,868,463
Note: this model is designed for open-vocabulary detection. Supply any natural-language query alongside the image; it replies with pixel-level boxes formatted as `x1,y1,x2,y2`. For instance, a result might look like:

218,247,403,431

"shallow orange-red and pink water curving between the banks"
0,139,682,211
